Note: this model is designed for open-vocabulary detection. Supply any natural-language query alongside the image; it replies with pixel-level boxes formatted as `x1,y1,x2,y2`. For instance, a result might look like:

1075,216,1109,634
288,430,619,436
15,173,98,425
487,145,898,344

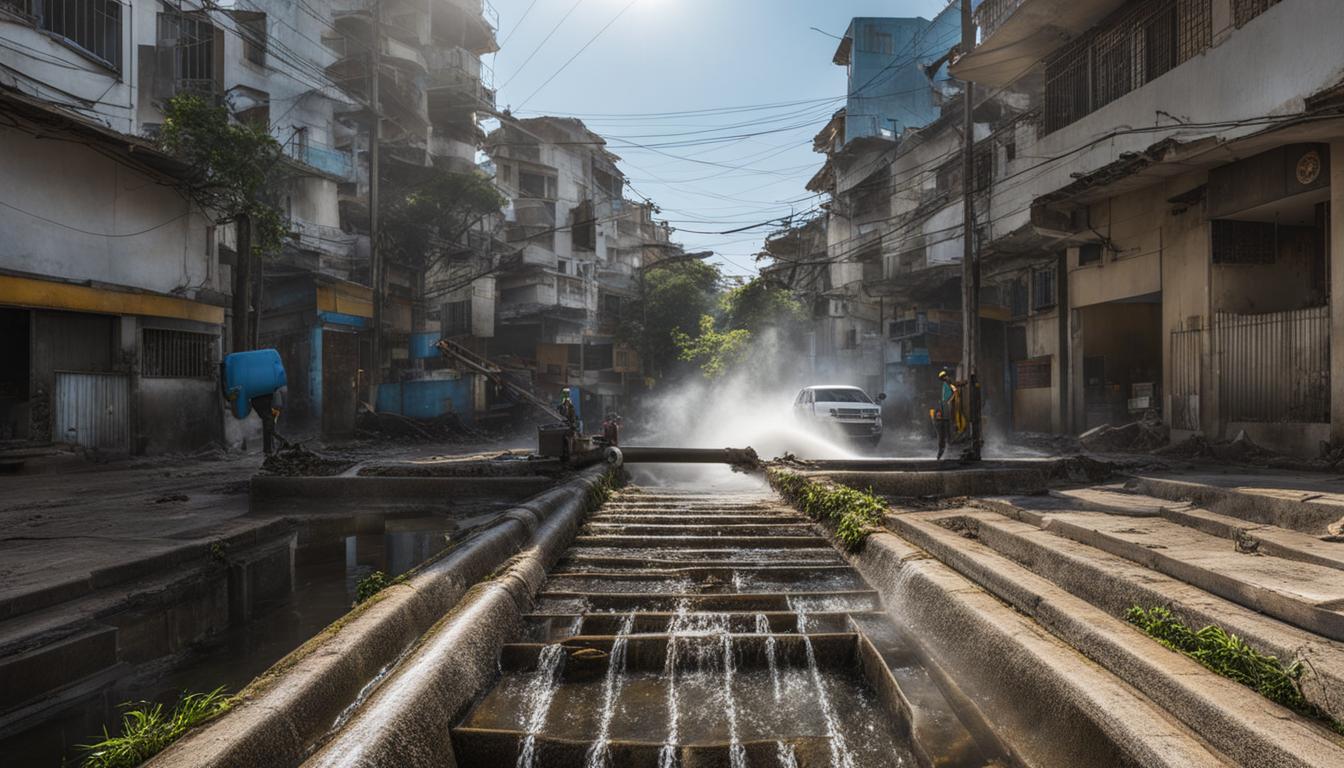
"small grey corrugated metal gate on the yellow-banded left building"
51,371,130,453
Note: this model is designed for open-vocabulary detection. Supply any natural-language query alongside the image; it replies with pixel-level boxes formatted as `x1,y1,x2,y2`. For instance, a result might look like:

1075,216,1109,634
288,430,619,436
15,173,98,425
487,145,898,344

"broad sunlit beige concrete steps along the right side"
888,491,1344,768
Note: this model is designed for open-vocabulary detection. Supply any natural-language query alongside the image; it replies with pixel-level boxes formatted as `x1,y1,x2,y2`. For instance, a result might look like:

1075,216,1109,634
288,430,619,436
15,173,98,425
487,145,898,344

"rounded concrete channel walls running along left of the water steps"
148,467,607,768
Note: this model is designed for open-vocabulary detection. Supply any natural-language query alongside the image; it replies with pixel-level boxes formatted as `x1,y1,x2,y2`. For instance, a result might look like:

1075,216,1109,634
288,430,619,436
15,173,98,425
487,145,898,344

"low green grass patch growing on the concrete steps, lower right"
1125,605,1344,734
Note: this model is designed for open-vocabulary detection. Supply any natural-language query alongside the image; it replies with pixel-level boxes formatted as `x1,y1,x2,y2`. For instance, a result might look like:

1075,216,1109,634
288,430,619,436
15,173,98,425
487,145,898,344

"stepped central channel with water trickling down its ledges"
453,490,1008,768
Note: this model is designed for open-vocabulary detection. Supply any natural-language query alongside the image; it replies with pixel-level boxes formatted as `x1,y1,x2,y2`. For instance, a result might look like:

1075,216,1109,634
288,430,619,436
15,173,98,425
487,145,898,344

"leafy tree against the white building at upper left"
159,93,286,254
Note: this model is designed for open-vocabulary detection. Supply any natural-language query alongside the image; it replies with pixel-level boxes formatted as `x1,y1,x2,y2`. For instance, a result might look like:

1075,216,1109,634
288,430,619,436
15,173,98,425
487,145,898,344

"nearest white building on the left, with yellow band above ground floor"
0,0,230,453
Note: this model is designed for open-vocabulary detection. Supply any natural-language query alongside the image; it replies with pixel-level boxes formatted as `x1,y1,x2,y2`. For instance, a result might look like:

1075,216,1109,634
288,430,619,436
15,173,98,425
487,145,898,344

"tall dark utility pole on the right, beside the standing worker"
961,0,982,460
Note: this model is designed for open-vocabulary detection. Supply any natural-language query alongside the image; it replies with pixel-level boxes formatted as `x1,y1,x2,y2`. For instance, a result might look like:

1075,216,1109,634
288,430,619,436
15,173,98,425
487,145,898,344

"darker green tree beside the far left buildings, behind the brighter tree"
617,260,720,379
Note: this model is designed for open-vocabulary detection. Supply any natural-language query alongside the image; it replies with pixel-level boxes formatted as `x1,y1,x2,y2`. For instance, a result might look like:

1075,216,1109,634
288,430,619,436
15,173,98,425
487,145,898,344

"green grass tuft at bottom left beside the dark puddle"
79,687,230,768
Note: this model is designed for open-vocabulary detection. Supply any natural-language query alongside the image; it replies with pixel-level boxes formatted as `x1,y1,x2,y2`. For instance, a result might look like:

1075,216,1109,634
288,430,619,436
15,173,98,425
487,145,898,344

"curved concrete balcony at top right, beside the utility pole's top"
950,0,1125,87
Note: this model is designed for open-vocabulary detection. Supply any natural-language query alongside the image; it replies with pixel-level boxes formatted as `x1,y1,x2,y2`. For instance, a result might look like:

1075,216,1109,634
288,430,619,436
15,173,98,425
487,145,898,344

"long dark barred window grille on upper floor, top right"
1044,0,1214,133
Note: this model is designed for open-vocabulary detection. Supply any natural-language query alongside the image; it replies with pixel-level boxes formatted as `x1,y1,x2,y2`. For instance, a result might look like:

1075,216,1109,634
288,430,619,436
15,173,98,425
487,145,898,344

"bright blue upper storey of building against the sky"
845,0,980,141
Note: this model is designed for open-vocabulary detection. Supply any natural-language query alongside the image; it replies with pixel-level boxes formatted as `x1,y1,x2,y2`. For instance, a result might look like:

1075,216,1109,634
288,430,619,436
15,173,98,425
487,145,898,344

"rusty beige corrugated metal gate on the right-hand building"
1214,307,1331,424
